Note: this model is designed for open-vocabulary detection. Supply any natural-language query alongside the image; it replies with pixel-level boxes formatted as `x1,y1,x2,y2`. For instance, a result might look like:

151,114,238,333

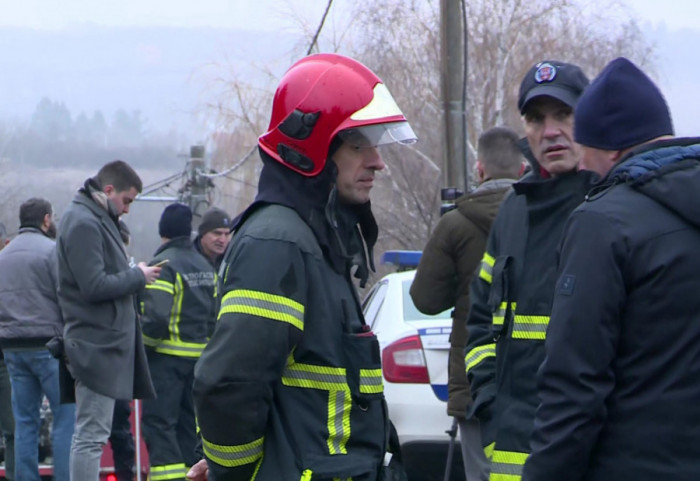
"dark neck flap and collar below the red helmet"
232,150,378,284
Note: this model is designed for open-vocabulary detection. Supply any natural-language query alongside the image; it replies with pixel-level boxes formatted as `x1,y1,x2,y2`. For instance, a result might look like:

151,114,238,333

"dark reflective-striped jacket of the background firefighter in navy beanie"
141,237,217,358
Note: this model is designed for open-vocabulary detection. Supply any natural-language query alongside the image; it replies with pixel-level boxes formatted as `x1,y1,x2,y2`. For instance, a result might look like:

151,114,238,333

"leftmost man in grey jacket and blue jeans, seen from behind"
0,197,75,481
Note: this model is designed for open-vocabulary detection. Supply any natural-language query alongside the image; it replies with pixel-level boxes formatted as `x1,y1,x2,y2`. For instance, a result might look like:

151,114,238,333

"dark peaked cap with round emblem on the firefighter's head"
518,60,589,114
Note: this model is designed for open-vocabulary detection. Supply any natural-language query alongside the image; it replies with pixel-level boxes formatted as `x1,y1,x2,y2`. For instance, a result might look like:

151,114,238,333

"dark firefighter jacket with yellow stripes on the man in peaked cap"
465,169,594,481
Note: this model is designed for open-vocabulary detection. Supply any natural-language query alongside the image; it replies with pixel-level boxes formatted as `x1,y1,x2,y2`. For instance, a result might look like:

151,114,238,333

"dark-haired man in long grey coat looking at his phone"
57,160,160,481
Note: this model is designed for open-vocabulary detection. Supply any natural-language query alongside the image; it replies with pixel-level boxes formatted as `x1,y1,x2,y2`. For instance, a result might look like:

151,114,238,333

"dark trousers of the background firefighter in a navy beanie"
141,350,199,481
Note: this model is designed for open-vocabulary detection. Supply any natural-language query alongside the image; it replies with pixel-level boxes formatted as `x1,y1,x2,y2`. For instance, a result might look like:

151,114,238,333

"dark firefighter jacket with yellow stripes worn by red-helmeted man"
194,155,388,481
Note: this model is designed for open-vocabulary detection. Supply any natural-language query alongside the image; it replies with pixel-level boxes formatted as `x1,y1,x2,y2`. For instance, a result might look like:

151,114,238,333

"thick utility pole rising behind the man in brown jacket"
440,0,467,192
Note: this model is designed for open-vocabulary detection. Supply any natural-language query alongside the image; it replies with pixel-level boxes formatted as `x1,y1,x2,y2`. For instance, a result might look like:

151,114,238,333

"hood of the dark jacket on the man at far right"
603,138,700,227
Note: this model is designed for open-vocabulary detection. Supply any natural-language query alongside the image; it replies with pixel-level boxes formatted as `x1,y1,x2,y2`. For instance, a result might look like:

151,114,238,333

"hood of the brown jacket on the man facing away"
455,179,515,232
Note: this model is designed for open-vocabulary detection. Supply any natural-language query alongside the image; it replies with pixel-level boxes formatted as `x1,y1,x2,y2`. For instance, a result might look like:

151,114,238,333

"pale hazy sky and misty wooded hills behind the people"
0,0,700,258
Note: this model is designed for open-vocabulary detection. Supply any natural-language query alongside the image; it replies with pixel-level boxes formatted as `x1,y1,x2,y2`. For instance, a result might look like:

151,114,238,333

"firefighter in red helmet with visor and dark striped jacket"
190,54,416,481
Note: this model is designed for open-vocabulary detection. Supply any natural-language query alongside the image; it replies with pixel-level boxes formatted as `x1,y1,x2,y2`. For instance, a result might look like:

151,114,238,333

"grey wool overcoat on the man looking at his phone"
56,190,155,399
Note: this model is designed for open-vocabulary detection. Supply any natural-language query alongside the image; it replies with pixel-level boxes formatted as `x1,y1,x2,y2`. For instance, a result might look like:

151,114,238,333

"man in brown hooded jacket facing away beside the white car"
410,127,525,481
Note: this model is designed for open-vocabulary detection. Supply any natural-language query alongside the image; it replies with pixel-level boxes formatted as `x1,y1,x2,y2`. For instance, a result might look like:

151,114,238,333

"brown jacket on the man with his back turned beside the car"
410,179,515,418
